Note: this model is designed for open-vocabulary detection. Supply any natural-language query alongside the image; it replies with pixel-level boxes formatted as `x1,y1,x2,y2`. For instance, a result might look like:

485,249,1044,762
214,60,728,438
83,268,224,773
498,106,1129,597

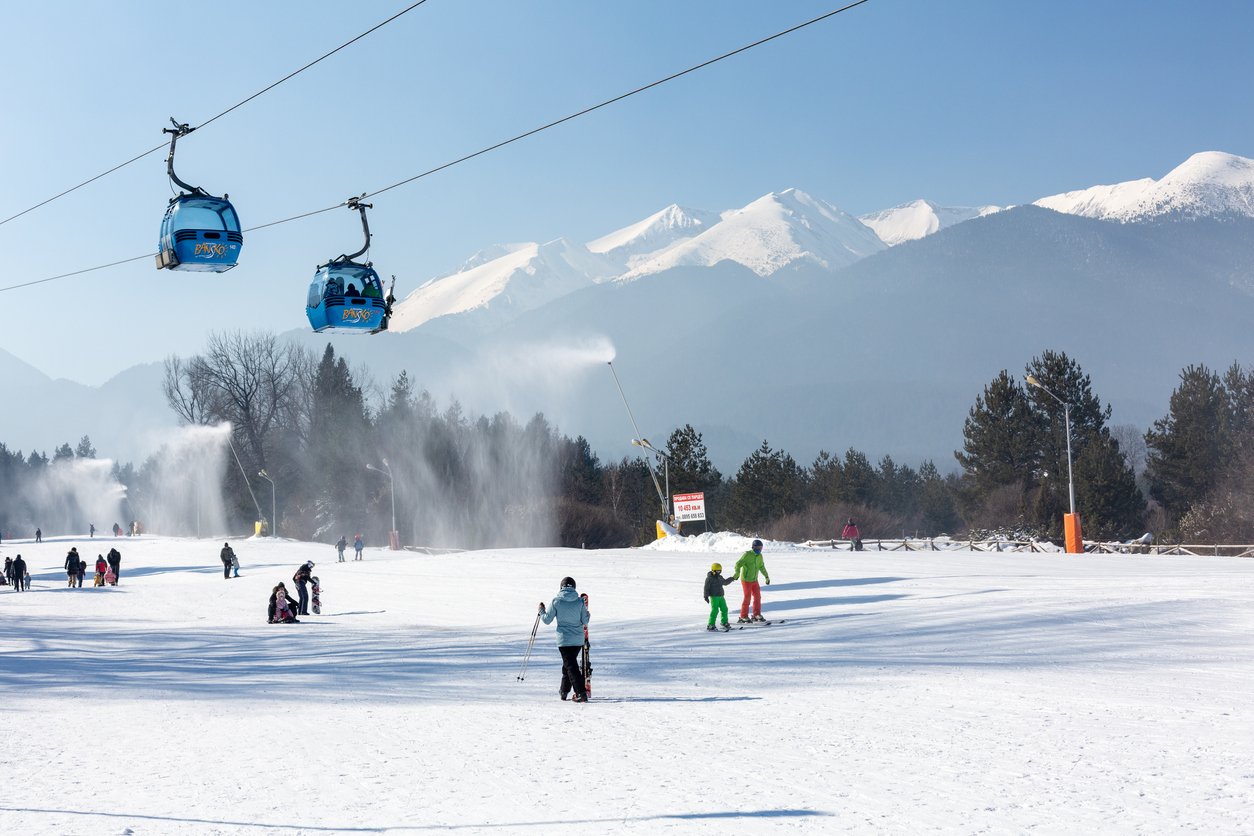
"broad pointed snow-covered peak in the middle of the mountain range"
622,189,884,280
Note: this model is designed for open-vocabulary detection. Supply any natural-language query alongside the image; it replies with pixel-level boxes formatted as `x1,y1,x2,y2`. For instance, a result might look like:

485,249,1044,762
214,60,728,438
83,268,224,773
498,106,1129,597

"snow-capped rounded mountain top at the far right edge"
1036,150,1254,223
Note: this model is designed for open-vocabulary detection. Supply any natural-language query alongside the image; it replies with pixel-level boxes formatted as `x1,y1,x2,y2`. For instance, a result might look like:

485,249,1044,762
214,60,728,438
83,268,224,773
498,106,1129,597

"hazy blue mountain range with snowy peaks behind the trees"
0,153,1254,473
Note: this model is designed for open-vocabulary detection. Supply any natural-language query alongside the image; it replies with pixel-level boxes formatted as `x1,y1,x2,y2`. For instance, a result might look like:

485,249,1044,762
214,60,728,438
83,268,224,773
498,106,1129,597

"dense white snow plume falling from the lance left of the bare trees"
132,424,231,536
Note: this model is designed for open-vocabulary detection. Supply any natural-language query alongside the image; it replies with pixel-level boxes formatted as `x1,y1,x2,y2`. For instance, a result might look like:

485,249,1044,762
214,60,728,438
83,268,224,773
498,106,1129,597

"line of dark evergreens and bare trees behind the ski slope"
0,333,1254,548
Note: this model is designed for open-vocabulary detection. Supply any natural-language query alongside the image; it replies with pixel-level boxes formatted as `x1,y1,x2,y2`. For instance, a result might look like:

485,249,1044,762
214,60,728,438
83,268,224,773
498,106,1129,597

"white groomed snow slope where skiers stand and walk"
0,535,1254,836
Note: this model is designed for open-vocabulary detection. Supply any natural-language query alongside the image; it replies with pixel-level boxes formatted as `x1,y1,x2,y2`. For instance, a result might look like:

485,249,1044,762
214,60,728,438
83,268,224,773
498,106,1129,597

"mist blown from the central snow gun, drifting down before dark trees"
390,337,614,548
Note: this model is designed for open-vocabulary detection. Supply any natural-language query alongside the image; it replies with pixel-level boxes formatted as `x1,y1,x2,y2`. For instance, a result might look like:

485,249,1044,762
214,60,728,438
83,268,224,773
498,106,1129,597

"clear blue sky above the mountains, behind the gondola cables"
0,0,1254,384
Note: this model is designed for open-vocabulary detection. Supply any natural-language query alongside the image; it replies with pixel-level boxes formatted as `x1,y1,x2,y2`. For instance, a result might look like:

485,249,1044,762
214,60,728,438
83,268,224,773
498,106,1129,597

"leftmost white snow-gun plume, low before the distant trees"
30,459,127,535
